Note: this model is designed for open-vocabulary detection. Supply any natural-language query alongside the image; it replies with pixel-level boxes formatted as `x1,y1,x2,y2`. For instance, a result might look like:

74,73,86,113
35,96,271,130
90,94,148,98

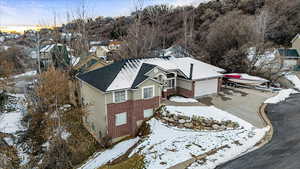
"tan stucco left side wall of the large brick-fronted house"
81,82,107,138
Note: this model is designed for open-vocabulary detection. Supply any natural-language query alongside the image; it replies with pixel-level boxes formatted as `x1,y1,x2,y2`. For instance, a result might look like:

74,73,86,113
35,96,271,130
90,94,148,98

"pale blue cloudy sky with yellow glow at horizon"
0,0,208,26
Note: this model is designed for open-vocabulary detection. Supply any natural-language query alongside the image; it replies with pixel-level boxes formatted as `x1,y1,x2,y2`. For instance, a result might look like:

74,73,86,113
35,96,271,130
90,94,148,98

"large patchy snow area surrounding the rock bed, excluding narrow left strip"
130,106,269,169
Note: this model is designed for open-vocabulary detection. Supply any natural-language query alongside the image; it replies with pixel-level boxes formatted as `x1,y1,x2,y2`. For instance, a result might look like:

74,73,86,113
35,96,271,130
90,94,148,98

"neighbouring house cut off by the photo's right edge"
275,34,300,70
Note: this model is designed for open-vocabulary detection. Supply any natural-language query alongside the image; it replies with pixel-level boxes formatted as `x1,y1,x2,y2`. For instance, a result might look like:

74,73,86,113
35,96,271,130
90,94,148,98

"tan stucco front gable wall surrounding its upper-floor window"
132,79,161,100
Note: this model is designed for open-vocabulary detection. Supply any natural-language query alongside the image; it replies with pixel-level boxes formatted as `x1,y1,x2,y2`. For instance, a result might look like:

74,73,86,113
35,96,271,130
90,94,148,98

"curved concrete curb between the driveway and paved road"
255,103,274,148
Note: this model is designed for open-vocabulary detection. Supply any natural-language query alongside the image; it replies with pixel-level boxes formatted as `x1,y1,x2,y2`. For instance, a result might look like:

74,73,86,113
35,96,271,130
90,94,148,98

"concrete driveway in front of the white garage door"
198,87,276,128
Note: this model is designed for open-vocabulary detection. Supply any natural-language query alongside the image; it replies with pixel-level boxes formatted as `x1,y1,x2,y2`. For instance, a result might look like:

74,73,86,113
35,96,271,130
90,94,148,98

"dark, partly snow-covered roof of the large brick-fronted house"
77,56,225,92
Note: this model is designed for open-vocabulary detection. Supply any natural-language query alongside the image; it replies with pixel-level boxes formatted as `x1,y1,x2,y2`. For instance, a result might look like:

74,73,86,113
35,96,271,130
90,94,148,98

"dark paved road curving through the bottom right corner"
217,94,300,169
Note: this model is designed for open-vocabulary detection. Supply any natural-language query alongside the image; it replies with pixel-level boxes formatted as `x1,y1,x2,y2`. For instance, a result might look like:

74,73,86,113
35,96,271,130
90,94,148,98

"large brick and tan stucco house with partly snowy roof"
77,56,224,142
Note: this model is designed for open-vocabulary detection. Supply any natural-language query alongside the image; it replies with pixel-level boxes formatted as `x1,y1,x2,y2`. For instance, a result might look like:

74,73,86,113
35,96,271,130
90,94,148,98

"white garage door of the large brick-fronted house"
195,79,218,97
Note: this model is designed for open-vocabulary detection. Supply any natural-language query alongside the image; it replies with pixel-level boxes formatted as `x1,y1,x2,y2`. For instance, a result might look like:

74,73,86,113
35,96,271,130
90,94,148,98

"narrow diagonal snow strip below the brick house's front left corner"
78,137,139,169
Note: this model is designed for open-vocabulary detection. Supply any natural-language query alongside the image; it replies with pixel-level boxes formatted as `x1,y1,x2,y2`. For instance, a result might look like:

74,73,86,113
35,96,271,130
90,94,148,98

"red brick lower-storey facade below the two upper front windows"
107,96,160,139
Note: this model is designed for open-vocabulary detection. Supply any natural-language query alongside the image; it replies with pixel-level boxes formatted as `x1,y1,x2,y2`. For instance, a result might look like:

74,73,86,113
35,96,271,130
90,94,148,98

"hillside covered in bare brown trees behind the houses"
65,0,300,71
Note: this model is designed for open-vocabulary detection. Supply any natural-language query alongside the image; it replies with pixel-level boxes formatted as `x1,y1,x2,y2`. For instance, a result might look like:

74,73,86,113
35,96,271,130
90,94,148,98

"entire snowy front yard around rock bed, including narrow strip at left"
80,106,270,169
